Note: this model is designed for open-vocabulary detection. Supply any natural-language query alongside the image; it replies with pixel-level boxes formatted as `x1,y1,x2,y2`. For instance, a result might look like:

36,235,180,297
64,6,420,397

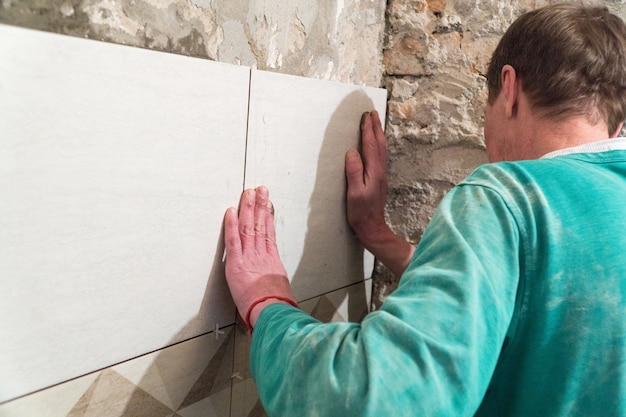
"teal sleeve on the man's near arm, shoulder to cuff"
250,185,520,417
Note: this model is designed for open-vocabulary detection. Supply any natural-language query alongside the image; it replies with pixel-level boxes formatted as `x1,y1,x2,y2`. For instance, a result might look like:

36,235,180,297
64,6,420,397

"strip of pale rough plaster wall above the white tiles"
0,0,385,87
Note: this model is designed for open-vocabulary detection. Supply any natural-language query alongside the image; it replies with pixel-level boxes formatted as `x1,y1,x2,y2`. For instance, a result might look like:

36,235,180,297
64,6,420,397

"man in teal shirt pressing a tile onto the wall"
225,5,626,417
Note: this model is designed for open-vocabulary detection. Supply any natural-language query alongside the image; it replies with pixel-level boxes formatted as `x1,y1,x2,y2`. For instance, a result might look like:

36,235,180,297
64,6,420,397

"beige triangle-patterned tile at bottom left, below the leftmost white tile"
0,326,235,417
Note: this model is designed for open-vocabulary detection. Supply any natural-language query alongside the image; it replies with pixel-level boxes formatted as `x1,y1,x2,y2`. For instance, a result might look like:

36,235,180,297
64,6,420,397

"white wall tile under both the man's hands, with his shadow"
246,70,387,300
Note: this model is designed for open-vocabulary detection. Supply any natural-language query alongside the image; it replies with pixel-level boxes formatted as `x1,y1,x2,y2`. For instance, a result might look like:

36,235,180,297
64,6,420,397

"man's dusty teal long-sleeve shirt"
251,145,626,417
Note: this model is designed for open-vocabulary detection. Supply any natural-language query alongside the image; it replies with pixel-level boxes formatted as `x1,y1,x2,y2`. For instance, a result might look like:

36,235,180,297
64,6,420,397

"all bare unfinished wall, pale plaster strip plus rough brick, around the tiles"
0,0,626,308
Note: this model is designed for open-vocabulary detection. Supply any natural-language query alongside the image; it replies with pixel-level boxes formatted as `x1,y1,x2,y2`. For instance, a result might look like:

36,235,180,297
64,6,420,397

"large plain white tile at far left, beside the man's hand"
0,25,249,402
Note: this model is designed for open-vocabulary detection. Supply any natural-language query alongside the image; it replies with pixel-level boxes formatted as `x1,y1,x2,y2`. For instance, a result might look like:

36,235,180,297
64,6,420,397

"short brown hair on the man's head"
487,4,626,135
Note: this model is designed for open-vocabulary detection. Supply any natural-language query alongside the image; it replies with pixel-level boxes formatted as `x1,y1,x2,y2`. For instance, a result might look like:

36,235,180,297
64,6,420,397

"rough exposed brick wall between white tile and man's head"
372,0,626,307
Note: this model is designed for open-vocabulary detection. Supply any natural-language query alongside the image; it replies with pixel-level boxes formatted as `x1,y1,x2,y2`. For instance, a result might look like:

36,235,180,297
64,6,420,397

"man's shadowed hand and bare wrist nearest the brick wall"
345,110,415,276
